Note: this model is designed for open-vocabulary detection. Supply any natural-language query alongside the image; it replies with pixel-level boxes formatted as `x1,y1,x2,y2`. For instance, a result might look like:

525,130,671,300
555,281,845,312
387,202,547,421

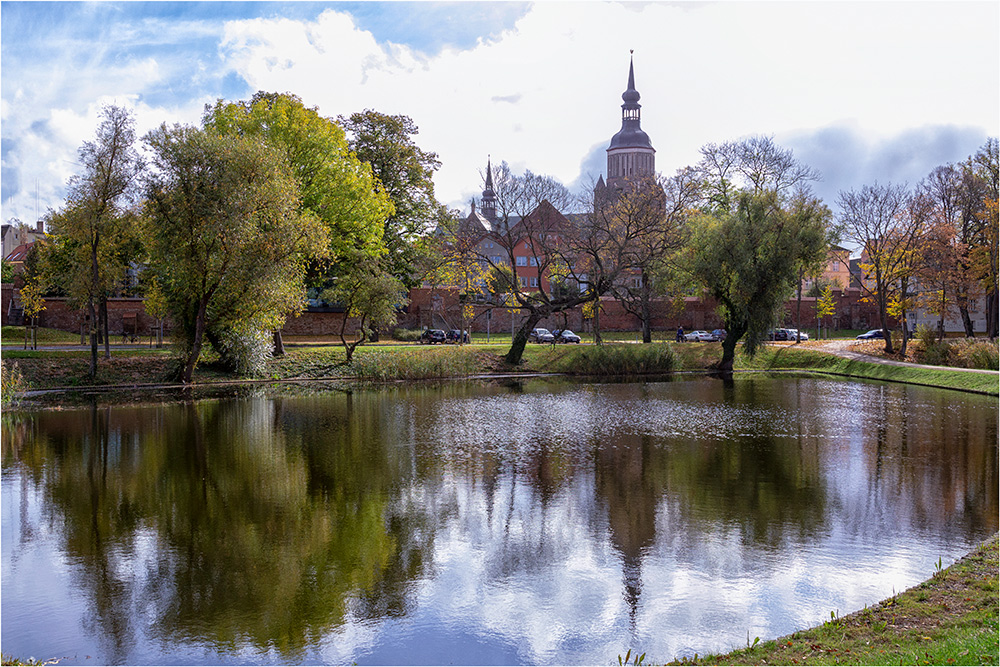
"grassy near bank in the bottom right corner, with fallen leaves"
668,536,1000,665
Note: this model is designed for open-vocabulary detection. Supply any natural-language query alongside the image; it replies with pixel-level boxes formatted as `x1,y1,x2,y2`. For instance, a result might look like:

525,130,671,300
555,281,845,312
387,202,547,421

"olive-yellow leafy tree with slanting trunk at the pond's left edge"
144,125,327,383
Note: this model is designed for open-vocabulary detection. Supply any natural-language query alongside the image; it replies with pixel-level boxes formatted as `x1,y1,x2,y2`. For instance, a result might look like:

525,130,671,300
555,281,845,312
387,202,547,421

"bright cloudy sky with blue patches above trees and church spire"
0,0,1000,228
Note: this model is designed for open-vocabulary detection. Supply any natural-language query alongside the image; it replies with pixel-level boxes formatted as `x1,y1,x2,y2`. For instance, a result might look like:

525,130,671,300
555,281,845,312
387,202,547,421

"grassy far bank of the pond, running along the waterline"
3,343,1000,395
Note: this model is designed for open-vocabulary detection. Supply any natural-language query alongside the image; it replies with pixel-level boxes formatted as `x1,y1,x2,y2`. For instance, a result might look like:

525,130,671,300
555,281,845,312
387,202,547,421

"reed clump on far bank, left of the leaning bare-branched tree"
351,345,482,382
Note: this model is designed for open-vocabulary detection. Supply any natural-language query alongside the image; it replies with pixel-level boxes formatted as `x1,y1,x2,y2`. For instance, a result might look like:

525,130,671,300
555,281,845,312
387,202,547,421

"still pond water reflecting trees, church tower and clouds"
0,376,998,665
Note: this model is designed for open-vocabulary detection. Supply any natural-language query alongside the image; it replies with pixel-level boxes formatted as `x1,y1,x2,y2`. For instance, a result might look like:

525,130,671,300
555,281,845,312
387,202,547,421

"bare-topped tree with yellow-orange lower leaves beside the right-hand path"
837,183,924,354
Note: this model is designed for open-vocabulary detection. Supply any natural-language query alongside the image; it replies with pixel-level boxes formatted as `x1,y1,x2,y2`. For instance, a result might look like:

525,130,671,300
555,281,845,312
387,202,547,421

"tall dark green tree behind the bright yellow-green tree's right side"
338,109,447,287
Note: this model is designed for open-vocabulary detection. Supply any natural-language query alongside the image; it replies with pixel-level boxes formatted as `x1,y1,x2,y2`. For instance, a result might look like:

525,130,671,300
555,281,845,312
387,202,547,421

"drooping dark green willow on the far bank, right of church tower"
687,190,829,372
